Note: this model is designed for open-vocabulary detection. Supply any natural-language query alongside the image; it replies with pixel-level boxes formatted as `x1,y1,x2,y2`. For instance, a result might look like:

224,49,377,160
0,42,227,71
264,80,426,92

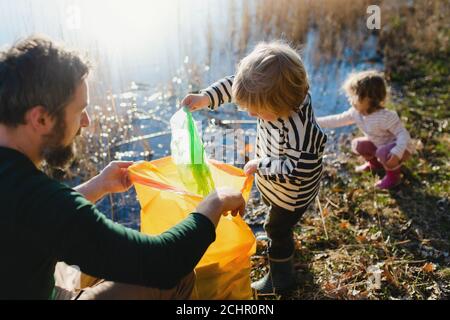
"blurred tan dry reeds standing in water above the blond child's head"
229,0,380,62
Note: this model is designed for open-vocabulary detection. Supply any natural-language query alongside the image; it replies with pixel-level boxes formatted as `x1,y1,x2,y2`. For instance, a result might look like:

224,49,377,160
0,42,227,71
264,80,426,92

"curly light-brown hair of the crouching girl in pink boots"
342,70,388,114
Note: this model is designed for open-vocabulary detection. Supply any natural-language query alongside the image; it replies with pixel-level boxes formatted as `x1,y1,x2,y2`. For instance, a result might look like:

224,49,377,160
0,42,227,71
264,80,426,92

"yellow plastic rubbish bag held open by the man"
129,157,256,300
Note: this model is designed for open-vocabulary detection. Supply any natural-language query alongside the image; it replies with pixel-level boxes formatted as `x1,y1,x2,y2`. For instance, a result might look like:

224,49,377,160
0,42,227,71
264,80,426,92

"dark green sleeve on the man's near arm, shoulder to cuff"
20,178,215,289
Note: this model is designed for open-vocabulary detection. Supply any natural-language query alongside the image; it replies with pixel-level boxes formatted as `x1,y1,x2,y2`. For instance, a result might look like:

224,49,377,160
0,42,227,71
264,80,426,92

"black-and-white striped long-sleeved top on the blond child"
202,77,327,212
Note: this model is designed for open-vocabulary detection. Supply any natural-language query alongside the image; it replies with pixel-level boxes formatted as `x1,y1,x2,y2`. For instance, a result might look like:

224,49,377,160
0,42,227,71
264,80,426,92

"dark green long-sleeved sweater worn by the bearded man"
0,147,215,299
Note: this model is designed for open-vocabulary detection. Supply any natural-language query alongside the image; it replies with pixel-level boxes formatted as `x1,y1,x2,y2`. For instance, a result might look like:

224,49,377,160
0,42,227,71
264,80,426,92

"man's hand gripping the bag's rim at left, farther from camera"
75,161,133,203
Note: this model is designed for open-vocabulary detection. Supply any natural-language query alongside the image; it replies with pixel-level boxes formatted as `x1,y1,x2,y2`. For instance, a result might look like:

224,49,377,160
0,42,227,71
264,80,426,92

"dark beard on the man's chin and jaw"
41,122,81,170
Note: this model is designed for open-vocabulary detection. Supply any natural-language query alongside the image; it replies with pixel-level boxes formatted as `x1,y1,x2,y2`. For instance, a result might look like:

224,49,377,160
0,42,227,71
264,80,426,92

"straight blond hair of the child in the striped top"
233,41,309,116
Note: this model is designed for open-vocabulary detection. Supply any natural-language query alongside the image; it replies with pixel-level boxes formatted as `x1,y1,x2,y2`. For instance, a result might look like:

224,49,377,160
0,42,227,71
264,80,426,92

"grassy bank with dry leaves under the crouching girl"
253,1,450,299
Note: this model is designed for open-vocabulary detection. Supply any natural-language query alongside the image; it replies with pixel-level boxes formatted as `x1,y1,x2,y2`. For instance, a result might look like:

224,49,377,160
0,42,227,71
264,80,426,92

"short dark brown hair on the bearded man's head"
0,36,89,127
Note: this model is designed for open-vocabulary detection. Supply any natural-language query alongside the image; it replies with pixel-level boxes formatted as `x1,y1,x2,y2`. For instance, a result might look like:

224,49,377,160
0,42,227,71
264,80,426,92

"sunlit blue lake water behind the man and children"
0,0,383,228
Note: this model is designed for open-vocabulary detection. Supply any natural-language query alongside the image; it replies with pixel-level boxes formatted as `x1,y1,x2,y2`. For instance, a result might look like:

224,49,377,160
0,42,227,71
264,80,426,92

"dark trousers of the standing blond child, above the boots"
262,197,312,259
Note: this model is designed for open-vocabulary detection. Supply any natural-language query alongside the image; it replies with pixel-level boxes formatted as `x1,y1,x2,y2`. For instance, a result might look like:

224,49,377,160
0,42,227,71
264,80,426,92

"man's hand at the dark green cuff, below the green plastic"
196,189,245,227
